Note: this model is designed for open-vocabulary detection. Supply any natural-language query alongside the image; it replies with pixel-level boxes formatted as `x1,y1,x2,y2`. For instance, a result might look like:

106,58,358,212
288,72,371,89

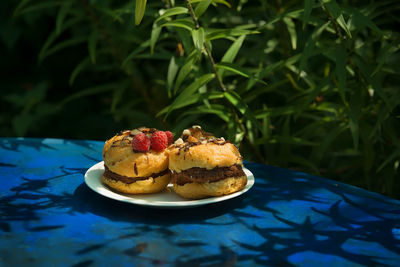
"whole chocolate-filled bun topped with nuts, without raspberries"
169,126,247,199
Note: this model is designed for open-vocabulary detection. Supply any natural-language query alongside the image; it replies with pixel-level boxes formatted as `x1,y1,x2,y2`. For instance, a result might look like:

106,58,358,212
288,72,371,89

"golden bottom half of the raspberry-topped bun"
101,173,171,194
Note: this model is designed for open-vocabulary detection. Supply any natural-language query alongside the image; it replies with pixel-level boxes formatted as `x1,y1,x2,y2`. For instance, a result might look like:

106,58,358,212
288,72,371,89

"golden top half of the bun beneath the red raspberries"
103,128,168,177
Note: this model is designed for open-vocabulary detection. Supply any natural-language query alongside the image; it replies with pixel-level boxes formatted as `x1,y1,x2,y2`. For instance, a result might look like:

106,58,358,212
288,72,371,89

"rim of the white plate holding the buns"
84,161,255,209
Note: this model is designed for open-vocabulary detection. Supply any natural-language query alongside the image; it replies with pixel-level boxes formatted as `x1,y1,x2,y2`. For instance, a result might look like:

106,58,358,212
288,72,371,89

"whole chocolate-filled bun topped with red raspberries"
102,127,173,194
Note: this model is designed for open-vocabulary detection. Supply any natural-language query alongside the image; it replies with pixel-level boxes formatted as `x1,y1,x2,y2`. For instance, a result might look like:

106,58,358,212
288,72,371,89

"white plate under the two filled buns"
85,161,254,209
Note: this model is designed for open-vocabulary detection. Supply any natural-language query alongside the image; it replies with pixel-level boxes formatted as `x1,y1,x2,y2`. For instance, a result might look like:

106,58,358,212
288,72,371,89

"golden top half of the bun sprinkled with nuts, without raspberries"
169,128,243,172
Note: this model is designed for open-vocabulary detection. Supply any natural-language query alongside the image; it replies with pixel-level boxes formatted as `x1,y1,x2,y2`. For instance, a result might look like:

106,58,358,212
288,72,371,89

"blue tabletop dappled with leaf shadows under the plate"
0,138,400,266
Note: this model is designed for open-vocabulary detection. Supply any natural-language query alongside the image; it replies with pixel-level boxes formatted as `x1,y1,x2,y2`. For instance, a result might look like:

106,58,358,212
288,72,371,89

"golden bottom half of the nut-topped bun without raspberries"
174,176,247,199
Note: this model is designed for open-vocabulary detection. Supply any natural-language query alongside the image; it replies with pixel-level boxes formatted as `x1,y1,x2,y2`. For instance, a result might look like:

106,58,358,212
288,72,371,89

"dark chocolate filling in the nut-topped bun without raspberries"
172,164,246,185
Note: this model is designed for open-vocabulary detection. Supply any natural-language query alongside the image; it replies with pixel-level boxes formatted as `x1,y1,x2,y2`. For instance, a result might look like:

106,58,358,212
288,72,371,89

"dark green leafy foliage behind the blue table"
0,0,400,198
